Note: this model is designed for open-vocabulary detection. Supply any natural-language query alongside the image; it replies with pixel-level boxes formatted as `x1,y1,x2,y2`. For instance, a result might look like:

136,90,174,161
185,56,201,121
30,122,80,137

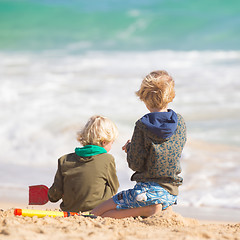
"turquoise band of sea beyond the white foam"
0,0,240,52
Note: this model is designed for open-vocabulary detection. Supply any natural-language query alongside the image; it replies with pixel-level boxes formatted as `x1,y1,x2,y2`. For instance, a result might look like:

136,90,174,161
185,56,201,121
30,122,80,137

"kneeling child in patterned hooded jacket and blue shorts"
92,71,186,218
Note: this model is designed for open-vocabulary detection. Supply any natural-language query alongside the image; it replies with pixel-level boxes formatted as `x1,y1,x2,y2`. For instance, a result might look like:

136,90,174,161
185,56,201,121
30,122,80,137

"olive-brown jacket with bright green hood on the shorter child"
48,145,119,212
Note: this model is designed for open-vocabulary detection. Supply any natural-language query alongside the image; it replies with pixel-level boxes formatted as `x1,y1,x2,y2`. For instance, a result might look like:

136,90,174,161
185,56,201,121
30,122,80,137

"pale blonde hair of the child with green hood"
77,115,118,147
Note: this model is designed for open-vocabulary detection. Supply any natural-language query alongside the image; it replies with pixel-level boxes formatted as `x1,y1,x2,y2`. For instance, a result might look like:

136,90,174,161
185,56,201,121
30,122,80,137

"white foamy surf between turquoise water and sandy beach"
0,51,240,207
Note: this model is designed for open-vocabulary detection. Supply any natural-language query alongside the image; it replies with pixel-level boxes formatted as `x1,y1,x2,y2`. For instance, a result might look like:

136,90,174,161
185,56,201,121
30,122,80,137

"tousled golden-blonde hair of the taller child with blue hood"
136,70,175,109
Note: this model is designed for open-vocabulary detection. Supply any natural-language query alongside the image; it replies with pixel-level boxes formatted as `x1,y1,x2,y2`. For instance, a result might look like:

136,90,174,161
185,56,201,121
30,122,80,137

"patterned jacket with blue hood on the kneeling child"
127,110,186,195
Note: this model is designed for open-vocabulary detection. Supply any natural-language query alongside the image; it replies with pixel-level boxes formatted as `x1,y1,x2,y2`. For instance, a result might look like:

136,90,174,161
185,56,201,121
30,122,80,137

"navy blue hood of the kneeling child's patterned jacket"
141,109,178,139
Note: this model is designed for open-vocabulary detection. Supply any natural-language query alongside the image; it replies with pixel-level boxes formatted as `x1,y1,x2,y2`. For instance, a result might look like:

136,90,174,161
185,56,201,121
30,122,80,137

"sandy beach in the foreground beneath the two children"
0,203,240,240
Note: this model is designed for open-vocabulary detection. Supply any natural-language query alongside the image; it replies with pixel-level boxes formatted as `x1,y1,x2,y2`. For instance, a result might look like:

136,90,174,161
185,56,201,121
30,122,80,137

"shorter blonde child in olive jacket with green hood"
48,116,119,212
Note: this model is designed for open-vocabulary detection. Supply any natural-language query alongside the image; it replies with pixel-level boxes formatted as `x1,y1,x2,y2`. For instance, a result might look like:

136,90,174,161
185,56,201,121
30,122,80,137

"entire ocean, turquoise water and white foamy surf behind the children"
0,0,240,209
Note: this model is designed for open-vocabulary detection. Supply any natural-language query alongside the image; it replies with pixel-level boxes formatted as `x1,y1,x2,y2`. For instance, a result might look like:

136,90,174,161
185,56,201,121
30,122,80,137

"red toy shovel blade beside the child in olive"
28,185,48,205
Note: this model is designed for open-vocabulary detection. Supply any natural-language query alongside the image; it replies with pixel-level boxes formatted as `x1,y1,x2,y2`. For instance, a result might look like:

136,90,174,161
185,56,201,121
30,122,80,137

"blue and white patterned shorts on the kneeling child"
112,182,177,210
